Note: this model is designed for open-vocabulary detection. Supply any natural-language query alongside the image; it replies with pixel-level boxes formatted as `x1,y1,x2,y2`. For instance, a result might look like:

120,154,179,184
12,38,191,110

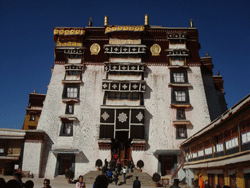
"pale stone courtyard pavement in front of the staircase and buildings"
0,175,153,188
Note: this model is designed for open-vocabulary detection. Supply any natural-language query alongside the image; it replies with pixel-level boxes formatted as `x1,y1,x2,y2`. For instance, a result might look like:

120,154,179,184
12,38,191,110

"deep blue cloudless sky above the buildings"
0,0,250,129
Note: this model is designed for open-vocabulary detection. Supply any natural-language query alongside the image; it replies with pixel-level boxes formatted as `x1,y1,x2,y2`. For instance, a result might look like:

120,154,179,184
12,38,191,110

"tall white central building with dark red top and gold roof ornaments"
32,15,226,179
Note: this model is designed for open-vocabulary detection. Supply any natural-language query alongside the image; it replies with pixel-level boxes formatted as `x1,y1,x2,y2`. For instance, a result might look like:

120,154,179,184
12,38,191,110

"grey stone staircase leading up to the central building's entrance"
83,169,154,186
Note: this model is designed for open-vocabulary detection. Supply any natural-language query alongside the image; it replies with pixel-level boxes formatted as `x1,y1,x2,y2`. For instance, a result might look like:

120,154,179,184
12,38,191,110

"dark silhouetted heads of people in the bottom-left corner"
0,172,51,188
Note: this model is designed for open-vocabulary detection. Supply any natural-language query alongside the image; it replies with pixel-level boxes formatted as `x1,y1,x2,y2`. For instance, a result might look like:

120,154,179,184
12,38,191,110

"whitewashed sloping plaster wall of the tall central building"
35,65,213,178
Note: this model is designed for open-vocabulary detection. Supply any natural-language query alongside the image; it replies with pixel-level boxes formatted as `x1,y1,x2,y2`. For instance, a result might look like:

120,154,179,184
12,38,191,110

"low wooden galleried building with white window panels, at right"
181,94,250,188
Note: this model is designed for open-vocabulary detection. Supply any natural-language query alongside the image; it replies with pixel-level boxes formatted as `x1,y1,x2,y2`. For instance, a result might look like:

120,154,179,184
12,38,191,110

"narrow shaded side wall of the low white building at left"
39,134,54,178
